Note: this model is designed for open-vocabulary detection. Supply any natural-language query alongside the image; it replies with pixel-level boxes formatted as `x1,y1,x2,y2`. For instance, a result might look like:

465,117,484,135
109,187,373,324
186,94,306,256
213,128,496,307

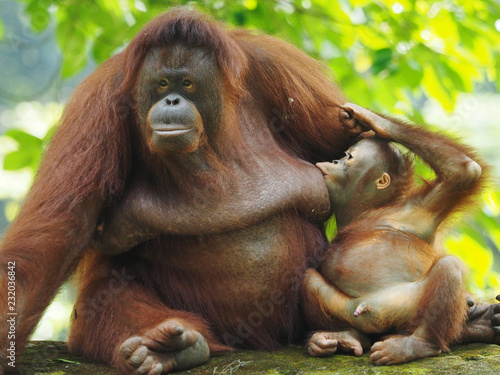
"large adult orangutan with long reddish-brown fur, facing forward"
0,9,498,375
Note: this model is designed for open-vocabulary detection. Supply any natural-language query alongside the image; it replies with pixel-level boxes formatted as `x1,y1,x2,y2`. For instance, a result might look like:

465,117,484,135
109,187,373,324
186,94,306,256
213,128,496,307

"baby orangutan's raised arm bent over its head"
344,104,483,240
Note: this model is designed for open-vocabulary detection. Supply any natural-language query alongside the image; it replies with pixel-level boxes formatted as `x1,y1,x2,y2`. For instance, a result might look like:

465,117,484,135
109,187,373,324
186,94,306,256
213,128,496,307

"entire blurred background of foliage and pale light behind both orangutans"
0,0,500,338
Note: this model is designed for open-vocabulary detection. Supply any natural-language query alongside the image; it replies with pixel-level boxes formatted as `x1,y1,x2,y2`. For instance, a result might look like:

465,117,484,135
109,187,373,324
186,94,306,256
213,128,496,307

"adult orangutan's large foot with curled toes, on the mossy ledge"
116,320,210,375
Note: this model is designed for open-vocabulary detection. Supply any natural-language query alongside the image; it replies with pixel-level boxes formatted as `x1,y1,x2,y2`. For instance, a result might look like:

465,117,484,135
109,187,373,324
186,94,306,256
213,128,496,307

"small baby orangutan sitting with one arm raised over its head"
303,104,486,365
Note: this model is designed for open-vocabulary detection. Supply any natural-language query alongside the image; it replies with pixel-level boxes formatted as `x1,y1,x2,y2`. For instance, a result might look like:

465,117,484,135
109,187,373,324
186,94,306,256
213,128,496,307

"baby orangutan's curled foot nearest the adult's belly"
307,330,370,357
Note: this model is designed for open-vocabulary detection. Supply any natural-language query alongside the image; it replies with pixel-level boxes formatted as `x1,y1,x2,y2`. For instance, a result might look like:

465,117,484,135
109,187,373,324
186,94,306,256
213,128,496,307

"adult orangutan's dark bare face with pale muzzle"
138,46,223,155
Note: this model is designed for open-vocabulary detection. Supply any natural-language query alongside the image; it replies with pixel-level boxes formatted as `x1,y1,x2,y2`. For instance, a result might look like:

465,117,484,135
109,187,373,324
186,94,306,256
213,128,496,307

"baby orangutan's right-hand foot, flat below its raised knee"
370,335,441,365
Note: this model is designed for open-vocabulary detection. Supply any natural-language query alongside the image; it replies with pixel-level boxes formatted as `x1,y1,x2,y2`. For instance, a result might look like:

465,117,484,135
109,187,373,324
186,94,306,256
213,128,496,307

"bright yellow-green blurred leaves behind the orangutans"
0,0,500,302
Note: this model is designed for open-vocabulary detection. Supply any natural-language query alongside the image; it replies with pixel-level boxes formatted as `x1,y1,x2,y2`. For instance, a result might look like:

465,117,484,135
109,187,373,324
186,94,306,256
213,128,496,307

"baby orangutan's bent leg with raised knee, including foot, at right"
371,256,467,365
